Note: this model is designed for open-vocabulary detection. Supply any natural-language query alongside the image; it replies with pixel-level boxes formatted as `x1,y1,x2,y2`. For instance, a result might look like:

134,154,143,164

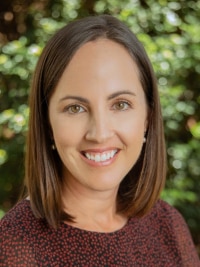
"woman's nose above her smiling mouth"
85,112,114,143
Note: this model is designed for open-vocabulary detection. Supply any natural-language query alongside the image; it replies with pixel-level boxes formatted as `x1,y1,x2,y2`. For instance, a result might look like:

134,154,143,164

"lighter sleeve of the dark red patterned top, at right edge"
162,204,200,267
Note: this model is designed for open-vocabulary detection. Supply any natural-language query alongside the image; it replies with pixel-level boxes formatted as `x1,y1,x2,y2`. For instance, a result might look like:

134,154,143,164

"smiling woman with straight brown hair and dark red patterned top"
0,15,200,267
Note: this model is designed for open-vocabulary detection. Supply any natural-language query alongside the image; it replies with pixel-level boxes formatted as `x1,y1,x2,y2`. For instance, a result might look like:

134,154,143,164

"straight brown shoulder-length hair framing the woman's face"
25,15,166,227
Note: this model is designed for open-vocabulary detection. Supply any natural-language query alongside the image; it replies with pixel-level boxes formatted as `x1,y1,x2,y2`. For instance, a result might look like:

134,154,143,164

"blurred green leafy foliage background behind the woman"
0,0,200,253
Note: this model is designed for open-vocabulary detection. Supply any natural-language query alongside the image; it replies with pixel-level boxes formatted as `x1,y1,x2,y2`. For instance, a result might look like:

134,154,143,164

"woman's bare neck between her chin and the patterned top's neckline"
63,182,127,232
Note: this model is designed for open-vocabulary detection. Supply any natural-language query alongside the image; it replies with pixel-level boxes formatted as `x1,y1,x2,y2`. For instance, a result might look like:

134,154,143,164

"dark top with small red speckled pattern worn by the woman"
0,200,200,267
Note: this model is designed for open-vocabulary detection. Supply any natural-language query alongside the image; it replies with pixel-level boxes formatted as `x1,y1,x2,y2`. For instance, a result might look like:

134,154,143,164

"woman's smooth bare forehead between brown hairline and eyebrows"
50,39,143,102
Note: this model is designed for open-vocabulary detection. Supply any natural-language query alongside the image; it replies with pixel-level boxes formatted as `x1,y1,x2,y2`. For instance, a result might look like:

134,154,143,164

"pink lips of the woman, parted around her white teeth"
81,148,120,167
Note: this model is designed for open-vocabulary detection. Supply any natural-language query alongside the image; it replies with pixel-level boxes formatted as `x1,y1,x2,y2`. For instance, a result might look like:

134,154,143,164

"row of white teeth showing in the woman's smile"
83,149,119,162
